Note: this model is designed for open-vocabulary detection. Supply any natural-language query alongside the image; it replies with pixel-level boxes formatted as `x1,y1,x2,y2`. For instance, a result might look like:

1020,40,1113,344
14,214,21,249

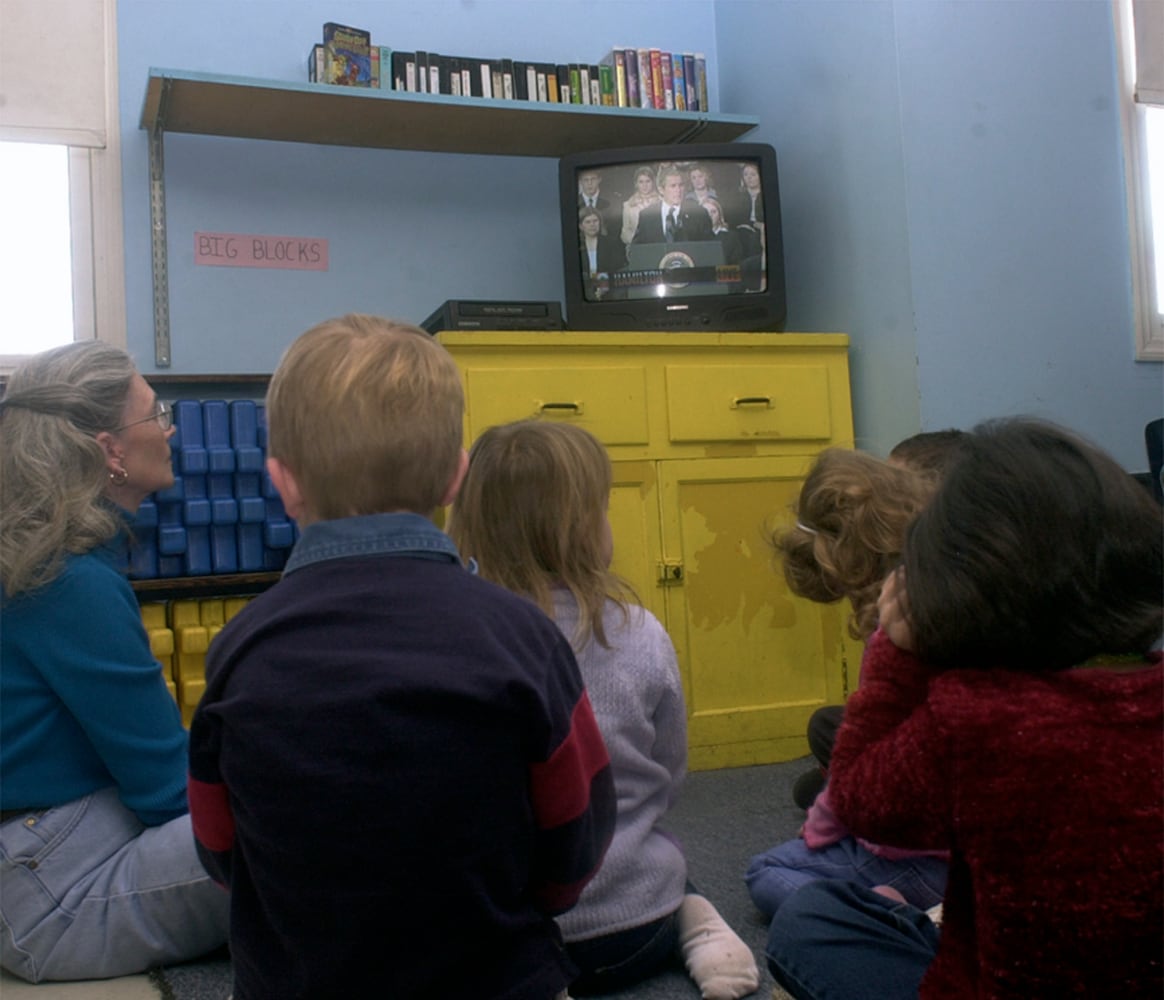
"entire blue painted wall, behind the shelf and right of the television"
119,0,1164,469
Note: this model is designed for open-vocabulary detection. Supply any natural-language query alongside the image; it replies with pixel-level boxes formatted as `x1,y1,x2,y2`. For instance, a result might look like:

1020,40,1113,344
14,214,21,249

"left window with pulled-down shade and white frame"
0,0,126,371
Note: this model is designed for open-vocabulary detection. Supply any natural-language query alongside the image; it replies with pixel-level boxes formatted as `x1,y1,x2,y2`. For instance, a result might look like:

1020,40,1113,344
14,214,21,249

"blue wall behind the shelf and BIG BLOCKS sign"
118,0,716,374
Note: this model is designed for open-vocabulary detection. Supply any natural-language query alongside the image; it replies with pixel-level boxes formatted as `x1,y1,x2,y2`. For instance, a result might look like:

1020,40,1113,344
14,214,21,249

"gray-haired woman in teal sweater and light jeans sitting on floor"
0,341,228,983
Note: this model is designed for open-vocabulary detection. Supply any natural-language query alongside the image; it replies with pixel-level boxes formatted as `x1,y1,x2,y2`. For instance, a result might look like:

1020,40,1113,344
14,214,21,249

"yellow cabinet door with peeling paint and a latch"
659,456,847,771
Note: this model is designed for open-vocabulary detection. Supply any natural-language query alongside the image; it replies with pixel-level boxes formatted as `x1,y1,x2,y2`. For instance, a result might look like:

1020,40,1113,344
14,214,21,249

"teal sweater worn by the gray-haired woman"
0,537,187,827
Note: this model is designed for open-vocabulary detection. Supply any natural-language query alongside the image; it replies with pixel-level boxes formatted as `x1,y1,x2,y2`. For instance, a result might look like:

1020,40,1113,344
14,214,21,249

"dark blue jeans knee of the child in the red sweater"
765,880,938,1000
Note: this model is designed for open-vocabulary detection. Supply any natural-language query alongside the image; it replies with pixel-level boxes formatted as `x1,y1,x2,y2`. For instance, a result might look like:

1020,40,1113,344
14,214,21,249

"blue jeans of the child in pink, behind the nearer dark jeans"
744,837,949,916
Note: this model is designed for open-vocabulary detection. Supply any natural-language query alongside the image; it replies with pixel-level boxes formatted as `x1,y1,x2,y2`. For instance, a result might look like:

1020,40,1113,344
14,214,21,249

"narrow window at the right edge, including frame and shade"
1113,0,1164,361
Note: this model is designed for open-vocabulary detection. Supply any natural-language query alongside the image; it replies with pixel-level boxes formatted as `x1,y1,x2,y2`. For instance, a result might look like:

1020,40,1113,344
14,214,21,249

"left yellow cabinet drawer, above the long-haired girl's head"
464,366,648,445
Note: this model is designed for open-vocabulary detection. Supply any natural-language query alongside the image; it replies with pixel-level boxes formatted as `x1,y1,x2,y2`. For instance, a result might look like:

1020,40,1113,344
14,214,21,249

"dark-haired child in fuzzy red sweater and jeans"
767,419,1164,1000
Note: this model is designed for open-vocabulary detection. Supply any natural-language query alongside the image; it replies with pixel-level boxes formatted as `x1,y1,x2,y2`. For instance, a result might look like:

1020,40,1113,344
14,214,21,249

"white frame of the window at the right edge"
1112,0,1164,361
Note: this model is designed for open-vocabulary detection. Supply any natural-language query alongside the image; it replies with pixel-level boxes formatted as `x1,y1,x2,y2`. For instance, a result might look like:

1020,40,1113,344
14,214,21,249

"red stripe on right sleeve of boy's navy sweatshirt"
530,692,610,830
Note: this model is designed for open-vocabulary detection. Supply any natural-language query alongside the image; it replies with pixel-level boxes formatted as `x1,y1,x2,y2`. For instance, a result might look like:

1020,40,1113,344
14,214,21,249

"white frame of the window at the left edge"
0,0,126,374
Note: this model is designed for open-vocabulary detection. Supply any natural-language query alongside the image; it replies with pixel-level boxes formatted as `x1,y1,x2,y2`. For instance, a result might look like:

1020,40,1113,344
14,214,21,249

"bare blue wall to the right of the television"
716,0,1164,470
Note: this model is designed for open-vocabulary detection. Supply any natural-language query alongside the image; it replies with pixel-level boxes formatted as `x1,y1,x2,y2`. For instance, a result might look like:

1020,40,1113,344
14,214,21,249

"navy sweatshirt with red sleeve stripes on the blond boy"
190,516,615,1000
